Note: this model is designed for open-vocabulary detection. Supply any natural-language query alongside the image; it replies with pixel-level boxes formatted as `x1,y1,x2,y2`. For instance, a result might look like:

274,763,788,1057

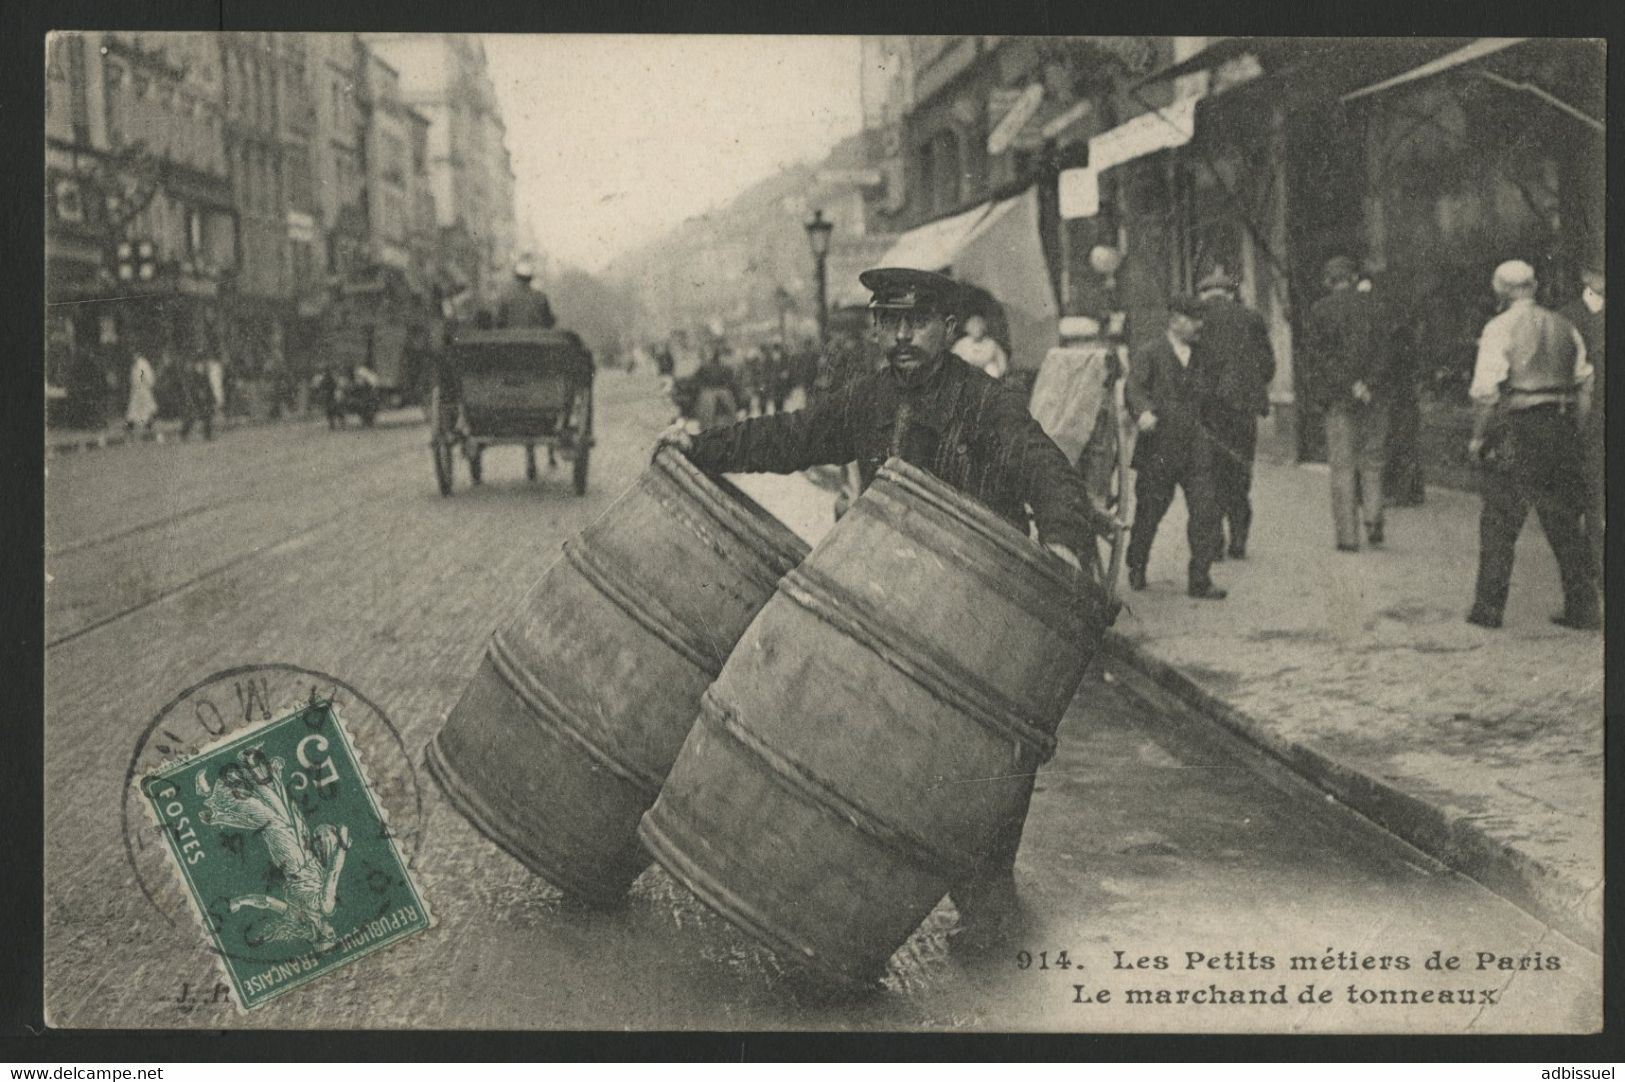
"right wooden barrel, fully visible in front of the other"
639,460,1105,985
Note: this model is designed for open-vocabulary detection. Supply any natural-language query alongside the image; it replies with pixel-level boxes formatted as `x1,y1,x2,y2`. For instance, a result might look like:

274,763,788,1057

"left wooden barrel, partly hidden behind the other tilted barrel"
427,450,808,903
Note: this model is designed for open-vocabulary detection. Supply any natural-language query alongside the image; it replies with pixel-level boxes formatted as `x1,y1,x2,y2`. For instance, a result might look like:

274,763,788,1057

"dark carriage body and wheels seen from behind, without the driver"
429,327,593,496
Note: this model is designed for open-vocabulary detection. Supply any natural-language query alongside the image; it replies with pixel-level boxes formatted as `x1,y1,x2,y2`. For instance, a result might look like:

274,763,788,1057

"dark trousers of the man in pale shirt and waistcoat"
1472,406,1597,622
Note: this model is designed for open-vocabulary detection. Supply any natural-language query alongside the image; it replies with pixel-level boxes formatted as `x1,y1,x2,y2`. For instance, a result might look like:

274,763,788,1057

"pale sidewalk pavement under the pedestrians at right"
735,461,1604,950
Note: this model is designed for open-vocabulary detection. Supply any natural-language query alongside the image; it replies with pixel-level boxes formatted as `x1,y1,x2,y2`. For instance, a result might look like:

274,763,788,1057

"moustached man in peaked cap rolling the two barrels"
660,268,1116,946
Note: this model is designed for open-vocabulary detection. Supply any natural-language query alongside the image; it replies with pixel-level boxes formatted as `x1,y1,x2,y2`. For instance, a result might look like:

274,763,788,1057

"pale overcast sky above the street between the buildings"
486,34,861,270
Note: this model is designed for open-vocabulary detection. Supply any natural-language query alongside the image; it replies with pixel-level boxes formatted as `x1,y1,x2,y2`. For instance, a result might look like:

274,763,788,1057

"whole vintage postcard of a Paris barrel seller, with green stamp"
39,28,1607,1035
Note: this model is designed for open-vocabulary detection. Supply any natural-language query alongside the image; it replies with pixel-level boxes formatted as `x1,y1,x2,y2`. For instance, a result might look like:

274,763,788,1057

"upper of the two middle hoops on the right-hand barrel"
778,565,1055,764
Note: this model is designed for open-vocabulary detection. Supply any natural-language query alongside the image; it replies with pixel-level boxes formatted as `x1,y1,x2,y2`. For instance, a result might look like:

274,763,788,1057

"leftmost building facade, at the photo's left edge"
46,32,241,424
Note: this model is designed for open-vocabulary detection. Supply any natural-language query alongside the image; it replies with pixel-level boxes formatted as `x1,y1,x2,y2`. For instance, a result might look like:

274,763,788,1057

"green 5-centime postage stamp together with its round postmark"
120,663,429,974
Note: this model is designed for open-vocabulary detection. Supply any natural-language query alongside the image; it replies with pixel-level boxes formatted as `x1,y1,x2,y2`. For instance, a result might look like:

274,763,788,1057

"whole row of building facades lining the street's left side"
44,32,514,426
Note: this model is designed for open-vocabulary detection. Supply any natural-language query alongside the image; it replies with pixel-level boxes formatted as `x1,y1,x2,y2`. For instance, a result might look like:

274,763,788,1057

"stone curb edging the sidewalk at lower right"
1105,632,1602,954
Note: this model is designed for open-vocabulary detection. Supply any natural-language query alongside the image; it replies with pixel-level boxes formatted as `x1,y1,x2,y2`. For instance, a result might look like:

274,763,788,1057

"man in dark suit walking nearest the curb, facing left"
1126,297,1225,599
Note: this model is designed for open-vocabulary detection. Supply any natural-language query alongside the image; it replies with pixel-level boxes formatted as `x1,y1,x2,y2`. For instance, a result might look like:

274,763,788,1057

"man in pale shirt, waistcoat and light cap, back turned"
1467,260,1602,630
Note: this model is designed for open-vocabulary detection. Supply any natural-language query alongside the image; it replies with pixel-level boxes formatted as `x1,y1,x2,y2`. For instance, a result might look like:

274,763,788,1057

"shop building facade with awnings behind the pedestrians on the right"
865,36,1604,458
